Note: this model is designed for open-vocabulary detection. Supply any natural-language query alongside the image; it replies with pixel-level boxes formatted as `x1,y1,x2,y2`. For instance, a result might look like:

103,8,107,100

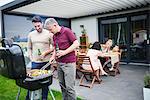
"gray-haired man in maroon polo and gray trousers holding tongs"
44,18,79,100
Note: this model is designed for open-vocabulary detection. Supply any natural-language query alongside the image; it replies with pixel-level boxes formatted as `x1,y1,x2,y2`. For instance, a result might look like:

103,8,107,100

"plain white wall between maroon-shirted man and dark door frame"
71,17,98,43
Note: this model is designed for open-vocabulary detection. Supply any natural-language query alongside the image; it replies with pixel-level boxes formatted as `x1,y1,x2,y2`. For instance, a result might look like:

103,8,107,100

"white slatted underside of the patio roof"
0,0,150,18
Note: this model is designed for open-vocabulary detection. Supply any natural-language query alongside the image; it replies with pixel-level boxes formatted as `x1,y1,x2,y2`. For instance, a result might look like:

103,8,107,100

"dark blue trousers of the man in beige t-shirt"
26,62,50,100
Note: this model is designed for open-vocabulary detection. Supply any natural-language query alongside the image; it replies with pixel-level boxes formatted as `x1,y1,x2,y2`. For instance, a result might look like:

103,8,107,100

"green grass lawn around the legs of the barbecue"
0,75,81,100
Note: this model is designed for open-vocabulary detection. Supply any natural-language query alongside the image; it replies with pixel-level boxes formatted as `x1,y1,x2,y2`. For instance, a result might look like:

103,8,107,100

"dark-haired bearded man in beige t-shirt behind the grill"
26,16,53,100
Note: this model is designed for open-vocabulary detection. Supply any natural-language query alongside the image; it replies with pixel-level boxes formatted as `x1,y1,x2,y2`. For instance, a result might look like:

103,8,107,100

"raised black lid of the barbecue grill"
0,44,26,79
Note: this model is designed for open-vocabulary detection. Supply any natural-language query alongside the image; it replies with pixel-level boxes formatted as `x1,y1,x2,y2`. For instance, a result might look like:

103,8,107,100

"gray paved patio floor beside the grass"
51,65,149,100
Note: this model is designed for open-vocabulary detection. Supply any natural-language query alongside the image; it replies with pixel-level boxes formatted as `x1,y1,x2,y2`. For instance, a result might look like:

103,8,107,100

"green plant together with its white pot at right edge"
143,73,150,100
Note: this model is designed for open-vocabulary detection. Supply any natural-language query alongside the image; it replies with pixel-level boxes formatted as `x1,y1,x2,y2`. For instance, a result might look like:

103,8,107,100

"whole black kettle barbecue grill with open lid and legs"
0,38,55,100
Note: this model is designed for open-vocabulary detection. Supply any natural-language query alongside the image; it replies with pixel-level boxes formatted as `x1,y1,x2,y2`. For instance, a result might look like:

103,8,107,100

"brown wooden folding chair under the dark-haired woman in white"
78,55,102,88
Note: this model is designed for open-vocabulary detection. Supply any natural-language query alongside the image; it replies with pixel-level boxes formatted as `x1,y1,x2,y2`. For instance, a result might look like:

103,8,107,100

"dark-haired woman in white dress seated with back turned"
82,42,108,76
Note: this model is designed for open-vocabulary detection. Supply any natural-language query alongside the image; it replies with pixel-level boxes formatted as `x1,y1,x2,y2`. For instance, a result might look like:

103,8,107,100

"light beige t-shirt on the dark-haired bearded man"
28,29,53,62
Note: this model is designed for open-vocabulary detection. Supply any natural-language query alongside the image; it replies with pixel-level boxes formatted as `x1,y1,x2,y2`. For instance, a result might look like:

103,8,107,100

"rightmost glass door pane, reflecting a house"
130,15,148,62
